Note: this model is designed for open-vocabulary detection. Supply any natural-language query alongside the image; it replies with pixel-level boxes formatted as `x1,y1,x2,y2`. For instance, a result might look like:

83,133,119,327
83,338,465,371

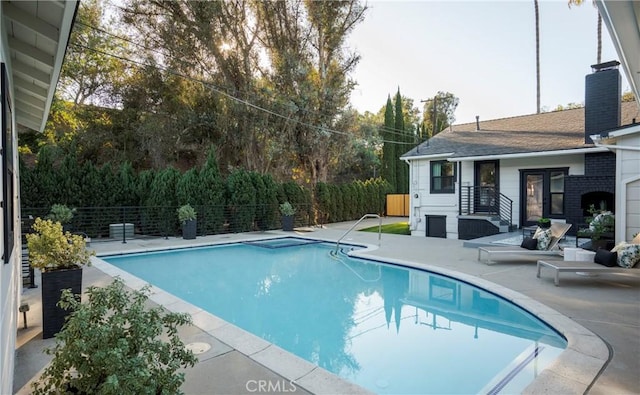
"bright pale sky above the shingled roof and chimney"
349,0,629,123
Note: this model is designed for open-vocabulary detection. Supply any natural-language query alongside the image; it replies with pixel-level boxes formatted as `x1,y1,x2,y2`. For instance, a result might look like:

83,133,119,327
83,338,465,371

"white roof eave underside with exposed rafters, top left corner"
0,0,78,131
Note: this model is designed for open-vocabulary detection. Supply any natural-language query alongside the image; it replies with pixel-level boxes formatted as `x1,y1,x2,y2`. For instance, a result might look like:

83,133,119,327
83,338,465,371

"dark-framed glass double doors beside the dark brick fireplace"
520,169,567,226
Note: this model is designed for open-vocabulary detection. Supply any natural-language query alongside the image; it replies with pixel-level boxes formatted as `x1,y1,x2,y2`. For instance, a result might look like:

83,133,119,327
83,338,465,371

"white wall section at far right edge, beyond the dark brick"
616,133,640,241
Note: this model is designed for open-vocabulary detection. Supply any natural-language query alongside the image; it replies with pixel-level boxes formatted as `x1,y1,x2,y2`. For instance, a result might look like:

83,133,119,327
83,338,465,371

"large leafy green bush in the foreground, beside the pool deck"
32,277,198,394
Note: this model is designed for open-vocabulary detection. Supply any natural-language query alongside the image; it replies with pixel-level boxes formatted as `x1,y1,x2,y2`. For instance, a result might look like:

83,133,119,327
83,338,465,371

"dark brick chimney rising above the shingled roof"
584,60,622,144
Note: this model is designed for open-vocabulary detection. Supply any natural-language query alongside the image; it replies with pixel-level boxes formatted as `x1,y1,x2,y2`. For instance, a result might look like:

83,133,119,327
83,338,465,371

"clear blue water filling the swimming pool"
103,238,566,394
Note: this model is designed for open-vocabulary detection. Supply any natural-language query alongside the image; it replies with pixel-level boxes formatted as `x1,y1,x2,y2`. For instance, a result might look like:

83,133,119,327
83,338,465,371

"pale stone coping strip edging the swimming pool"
91,235,610,394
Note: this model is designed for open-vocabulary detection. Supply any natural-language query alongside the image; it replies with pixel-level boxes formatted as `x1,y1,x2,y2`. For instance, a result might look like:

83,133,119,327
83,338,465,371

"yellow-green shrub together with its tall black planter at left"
26,218,95,339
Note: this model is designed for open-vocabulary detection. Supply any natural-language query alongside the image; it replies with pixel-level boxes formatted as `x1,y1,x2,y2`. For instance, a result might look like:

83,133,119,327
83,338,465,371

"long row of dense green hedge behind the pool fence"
20,150,391,235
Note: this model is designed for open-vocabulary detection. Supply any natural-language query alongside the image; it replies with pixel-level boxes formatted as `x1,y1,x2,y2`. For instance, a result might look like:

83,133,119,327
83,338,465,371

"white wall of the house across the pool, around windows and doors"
410,153,584,239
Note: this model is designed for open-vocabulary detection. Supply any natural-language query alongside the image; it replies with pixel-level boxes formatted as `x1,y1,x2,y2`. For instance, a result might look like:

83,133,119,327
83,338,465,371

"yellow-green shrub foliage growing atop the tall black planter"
27,218,95,271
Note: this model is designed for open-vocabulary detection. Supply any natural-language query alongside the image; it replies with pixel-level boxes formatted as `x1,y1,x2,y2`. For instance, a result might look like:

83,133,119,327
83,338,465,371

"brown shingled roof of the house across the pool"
402,101,640,159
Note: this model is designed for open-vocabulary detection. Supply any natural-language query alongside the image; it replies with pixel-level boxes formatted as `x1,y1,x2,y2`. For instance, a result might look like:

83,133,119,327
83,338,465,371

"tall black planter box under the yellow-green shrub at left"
42,267,82,339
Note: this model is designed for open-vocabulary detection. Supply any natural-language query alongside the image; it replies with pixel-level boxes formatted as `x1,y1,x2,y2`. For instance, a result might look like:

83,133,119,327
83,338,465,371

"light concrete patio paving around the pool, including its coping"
14,218,640,395
